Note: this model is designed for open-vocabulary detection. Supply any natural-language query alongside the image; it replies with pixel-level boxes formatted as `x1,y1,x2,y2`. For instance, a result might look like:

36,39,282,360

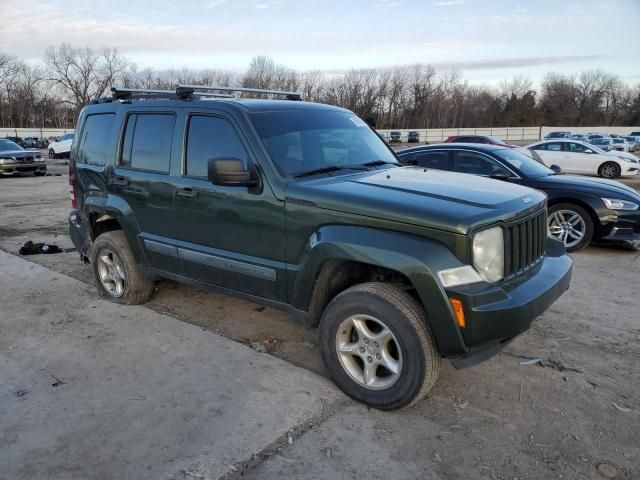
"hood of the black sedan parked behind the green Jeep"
529,175,640,202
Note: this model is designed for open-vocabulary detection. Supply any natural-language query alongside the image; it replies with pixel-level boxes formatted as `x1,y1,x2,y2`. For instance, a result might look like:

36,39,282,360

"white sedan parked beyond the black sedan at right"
524,140,640,178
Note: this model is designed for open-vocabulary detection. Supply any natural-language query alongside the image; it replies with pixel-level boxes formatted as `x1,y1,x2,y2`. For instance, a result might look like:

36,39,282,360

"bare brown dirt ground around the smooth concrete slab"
0,162,640,480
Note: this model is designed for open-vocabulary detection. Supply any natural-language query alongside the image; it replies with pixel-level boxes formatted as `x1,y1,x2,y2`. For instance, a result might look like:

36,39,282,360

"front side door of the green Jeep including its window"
174,114,285,300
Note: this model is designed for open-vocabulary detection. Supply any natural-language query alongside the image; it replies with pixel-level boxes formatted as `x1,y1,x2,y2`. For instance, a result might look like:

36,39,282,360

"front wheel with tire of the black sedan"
547,203,594,252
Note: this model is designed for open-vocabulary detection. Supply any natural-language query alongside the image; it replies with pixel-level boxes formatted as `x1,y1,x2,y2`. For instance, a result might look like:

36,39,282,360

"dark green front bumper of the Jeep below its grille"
447,240,573,366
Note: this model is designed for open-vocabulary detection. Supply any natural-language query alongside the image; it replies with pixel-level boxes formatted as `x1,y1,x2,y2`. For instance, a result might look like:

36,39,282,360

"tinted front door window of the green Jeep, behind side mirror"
186,116,247,178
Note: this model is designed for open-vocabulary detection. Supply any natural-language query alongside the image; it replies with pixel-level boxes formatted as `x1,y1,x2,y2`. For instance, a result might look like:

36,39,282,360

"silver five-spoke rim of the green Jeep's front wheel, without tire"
336,315,403,390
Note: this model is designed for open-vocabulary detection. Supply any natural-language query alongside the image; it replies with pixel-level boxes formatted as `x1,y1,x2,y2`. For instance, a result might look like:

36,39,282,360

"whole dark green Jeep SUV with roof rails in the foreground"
69,86,571,409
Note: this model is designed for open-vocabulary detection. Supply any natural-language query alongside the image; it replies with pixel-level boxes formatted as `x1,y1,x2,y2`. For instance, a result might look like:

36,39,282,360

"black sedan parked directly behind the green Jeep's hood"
398,145,640,251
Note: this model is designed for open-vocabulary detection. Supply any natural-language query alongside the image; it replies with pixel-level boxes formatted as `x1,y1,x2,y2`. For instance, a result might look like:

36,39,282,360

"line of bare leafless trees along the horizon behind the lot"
0,44,640,129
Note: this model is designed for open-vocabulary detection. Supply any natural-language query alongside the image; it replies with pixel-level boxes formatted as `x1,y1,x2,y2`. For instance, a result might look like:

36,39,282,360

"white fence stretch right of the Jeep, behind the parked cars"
378,127,640,144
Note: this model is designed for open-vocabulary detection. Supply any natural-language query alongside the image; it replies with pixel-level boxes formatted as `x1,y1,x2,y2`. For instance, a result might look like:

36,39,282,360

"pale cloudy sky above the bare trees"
0,0,640,84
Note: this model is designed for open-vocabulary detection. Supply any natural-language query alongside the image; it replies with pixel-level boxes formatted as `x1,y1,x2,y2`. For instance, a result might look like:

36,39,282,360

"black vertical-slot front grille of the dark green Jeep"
504,210,547,279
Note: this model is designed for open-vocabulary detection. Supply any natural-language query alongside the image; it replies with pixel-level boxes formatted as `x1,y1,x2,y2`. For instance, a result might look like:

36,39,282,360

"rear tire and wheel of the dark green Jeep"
89,230,153,305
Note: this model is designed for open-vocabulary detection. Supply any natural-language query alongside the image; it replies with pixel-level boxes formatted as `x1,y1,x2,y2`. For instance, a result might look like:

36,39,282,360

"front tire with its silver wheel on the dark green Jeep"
320,282,440,410
